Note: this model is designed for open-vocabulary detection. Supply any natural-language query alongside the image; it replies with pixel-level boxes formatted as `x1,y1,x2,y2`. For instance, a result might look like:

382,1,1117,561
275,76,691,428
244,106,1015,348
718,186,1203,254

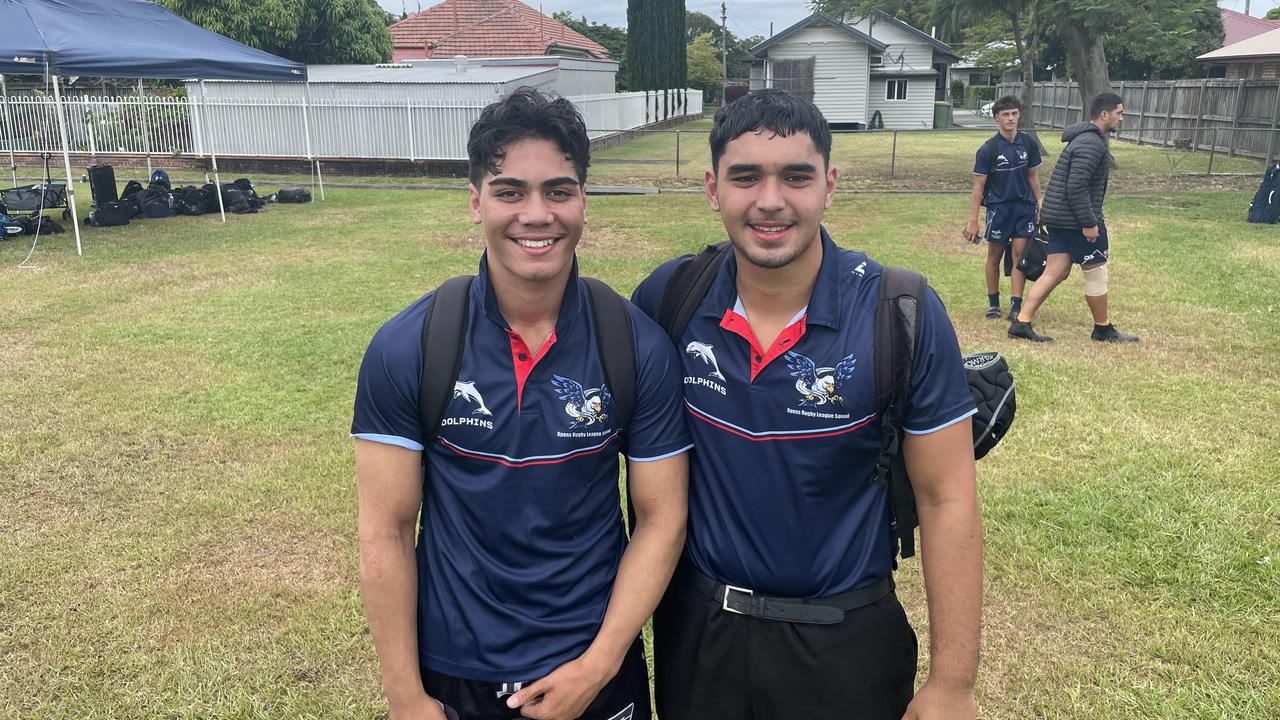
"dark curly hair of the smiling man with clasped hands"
467,87,591,188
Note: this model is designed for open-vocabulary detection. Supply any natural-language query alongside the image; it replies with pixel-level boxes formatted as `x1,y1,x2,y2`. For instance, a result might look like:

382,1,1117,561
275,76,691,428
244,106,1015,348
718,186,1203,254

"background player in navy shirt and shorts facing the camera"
964,95,1041,320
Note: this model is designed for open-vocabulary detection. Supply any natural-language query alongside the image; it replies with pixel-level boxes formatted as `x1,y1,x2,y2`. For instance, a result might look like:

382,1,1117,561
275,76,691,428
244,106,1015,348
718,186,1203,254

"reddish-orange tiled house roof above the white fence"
387,0,609,63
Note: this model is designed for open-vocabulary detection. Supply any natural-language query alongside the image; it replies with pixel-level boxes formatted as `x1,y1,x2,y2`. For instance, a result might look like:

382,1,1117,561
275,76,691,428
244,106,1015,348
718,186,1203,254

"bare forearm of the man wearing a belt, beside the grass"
918,496,982,689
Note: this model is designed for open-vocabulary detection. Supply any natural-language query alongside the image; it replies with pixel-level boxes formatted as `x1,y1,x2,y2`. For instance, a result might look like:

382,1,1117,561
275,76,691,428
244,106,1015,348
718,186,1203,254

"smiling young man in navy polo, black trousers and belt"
632,91,982,720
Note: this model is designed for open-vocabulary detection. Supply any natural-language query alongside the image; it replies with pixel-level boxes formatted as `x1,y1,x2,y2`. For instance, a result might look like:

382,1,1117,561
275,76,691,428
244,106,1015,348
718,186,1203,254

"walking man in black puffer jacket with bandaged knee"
1009,92,1138,342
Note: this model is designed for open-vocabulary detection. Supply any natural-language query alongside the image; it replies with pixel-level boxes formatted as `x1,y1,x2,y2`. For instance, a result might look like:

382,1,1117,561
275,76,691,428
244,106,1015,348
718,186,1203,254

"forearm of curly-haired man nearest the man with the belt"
584,506,685,676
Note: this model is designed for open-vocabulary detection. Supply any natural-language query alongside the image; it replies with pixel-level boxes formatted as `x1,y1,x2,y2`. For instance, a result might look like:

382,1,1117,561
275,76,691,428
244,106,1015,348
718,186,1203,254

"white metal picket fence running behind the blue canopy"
0,90,703,160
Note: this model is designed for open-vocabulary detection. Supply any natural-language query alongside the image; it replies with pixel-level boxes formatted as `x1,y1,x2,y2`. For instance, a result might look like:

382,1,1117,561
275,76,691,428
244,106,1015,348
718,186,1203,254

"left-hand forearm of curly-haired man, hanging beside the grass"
360,528,424,706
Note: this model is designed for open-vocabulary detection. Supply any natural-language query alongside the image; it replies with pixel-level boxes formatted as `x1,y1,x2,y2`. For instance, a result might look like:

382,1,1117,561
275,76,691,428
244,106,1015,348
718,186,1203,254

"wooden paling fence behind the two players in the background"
996,79,1280,164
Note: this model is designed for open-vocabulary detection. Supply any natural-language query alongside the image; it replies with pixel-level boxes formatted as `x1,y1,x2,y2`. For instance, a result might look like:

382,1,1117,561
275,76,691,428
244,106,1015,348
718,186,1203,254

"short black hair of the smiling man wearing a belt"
709,90,831,173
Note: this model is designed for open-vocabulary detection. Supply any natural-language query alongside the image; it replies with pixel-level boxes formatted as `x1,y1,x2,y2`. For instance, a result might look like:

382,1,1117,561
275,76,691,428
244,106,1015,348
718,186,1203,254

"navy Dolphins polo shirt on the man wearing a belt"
632,229,975,597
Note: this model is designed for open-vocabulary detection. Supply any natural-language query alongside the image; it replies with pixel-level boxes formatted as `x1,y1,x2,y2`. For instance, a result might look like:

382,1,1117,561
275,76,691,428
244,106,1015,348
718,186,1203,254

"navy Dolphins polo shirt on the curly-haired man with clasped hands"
351,259,690,682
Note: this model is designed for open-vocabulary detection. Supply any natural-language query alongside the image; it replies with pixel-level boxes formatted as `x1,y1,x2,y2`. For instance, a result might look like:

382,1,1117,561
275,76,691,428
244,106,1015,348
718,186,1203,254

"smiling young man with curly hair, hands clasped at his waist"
351,90,690,720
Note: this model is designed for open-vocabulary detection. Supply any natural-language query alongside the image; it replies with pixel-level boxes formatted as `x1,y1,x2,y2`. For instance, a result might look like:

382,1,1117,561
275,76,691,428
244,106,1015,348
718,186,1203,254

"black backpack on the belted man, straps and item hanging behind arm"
654,242,1016,559
